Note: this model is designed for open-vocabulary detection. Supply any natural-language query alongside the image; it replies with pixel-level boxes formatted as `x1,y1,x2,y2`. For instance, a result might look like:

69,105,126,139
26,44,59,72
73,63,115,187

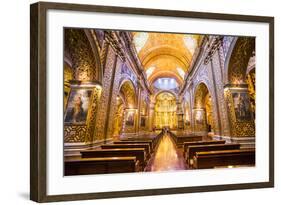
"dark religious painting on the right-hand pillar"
232,92,252,121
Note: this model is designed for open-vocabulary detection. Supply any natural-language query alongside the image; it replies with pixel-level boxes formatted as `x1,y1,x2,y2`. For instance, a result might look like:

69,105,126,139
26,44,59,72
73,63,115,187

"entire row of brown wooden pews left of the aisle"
64,133,163,176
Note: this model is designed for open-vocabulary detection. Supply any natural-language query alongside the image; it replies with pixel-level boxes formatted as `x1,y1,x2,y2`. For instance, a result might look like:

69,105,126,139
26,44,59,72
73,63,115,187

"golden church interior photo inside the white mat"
63,28,256,176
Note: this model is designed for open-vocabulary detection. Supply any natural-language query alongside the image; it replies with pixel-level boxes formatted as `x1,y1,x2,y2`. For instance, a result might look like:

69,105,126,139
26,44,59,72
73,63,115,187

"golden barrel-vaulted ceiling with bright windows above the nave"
132,32,203,85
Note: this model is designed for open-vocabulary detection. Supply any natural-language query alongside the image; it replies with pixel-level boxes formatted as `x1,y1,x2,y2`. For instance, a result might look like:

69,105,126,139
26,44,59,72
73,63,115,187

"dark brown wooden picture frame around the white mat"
30,2,274,202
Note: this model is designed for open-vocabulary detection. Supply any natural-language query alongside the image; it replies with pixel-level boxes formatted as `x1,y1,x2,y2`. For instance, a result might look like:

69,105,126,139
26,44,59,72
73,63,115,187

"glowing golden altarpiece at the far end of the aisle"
154,92,177,129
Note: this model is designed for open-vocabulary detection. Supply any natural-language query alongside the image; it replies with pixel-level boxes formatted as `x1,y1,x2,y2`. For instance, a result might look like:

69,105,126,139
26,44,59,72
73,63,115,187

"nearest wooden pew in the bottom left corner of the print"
64,157,140,176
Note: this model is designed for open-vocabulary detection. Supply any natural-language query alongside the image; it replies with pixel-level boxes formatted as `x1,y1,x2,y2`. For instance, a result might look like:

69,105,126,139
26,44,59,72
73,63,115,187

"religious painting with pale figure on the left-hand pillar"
64,89,92,124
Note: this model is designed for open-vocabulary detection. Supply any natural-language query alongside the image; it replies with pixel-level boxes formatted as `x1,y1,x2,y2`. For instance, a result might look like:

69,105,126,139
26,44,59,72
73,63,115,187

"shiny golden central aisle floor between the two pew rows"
146,134,186,171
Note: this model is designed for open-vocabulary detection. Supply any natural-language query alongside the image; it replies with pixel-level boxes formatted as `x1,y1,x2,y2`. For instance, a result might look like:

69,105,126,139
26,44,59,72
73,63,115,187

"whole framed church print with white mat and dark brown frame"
30,2,274,202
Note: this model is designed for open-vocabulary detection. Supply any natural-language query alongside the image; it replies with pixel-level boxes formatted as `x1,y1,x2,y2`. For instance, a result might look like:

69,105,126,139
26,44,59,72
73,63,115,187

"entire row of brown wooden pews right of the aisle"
167,132,255,169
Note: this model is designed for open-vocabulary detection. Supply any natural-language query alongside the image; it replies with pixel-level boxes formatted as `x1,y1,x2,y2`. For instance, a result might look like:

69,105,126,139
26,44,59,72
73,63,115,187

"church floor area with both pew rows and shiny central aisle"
65,131,255,176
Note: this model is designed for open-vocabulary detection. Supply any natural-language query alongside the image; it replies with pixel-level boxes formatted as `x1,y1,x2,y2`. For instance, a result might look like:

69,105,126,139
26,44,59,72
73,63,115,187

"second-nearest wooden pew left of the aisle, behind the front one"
81,148,147,170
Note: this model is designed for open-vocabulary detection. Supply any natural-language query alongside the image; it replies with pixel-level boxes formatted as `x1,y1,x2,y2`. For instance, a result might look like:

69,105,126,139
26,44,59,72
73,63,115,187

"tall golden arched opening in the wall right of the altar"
193,83,214,132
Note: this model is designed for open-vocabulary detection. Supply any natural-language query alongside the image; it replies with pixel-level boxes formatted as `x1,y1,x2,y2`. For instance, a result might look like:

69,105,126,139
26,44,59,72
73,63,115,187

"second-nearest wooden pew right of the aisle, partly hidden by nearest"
186,144,240,167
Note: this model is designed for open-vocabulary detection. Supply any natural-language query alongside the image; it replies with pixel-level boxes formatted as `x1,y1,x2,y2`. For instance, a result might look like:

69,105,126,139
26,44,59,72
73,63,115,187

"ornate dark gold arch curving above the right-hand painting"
225,37,255,84
